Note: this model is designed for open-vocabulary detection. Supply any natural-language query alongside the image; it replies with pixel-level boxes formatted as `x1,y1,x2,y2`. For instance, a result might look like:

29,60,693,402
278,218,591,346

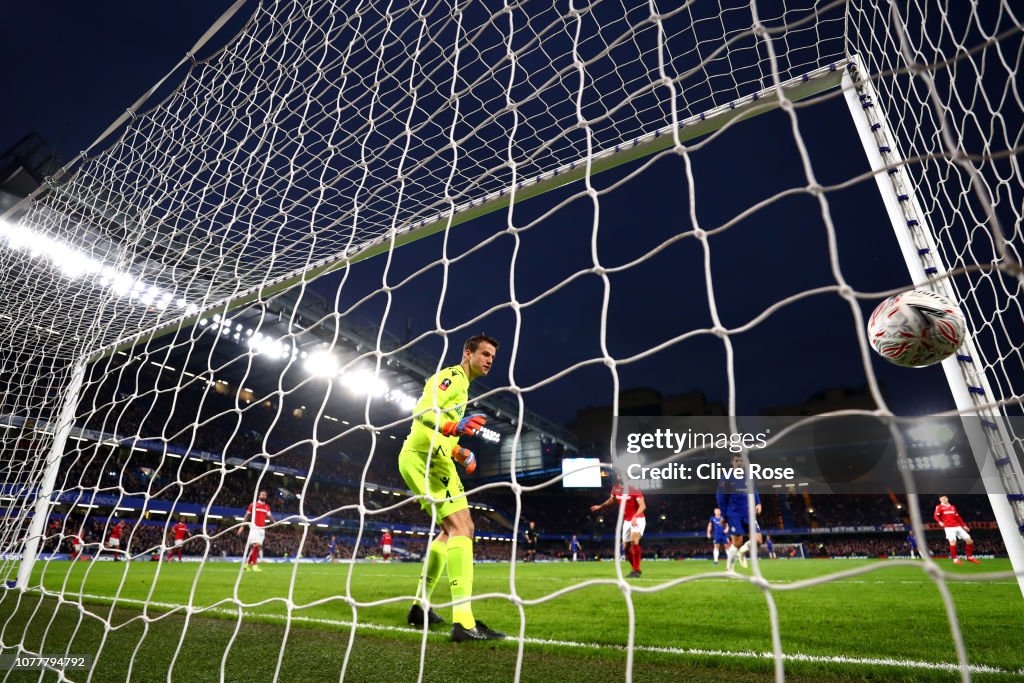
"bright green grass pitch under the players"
0,560,1024,683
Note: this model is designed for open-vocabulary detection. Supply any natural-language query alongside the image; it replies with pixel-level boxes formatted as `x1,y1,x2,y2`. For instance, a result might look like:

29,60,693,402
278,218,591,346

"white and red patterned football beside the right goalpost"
867,290,967,368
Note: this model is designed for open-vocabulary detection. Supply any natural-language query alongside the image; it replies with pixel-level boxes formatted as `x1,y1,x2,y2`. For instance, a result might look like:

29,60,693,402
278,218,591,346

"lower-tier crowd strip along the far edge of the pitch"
24,486,1004,559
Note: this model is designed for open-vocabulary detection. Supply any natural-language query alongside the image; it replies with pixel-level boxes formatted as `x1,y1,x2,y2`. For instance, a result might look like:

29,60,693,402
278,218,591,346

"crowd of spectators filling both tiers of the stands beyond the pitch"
4,364,1001,559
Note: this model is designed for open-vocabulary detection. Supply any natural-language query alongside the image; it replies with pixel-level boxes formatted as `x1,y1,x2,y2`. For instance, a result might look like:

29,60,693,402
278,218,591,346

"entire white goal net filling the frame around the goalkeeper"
0,0,1024,680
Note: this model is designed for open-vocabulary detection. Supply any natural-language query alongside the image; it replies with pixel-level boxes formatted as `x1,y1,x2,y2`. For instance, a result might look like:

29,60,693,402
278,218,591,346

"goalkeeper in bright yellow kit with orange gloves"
398,335,505,642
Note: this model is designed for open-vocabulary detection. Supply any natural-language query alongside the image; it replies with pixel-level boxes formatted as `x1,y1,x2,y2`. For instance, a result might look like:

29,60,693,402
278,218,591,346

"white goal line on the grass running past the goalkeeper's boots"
41,593,1024,676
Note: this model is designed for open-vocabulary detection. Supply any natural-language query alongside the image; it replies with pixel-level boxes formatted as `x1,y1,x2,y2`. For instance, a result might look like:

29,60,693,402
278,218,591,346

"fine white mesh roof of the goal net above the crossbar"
0,3,841,357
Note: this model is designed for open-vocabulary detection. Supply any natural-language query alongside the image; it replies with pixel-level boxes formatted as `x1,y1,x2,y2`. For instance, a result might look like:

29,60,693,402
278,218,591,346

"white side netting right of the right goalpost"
848,3,1024,511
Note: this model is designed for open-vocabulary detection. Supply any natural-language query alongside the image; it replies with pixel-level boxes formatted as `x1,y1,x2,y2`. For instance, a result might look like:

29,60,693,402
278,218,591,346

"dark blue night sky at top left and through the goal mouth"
0,0,952,430
